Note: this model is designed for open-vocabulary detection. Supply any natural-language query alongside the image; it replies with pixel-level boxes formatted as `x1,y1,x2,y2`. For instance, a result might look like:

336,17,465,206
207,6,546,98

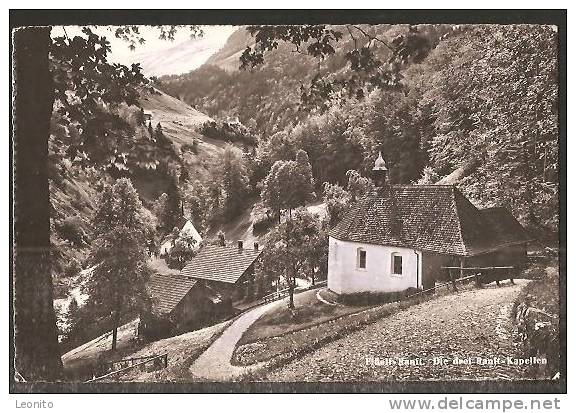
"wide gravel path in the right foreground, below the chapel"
265,280,527,381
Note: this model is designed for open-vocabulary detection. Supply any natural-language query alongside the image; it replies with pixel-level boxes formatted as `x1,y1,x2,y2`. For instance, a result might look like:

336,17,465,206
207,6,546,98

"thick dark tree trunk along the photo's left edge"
13,27,62,381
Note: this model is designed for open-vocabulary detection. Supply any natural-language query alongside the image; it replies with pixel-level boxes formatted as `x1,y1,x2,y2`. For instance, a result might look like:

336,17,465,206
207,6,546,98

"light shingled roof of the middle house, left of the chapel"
182,245,262,284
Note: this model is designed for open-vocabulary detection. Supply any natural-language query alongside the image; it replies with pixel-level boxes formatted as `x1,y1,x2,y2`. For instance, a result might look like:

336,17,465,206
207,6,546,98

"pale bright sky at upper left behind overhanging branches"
57,26,237,76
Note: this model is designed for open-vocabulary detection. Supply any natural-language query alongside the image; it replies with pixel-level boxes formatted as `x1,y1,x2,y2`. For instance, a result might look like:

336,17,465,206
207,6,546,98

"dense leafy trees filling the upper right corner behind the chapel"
410,25,558,235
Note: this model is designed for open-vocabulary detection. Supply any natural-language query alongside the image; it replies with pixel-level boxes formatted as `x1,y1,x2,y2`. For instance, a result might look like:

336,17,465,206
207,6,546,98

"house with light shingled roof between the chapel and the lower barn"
182,241,262,304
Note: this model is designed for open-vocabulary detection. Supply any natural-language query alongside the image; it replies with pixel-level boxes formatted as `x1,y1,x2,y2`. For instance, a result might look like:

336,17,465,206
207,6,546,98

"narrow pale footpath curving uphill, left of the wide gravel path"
190,300,285,381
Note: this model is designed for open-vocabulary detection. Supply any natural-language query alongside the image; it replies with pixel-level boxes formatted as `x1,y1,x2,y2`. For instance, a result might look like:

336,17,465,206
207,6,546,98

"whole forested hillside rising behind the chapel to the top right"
162,25,558,238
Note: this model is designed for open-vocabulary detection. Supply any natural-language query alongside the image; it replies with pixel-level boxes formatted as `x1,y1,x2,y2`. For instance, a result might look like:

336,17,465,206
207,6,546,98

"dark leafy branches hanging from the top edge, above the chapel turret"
240,25,432,109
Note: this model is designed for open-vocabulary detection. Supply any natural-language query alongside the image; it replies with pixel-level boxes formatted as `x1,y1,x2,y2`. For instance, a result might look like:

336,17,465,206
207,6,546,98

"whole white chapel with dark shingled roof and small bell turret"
328,154,531,295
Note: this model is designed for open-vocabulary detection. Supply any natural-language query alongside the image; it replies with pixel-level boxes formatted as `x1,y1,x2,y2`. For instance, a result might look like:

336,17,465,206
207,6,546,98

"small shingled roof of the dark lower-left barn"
148,274,197,314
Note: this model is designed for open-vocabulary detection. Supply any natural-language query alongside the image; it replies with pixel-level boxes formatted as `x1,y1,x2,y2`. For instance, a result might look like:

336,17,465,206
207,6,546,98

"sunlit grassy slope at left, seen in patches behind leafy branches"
50,92,234,298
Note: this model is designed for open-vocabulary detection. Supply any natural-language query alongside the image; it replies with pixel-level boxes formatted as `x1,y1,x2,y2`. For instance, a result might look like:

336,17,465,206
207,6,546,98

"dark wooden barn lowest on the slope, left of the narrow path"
139,274,231,338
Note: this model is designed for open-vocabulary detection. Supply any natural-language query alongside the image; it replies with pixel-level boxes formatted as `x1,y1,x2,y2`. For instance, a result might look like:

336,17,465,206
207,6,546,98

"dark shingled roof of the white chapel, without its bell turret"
330,185,530,256
